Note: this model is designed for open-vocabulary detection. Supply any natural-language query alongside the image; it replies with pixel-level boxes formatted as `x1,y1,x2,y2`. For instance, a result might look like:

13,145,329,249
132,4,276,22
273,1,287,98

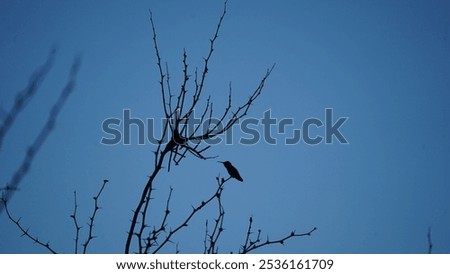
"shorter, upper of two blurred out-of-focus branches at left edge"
0,48,56,150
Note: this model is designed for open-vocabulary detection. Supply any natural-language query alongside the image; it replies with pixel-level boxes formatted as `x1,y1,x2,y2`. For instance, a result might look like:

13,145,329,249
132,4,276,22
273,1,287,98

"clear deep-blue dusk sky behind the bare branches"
0,0,450,253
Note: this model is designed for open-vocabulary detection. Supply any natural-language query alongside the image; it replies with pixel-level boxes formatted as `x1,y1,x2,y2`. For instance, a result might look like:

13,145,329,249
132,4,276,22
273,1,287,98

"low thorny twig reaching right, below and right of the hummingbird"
239,217,317,254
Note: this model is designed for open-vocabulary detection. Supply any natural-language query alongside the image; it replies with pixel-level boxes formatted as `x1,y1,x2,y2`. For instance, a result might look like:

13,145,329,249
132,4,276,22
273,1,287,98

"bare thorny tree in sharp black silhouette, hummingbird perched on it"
121,1,316,253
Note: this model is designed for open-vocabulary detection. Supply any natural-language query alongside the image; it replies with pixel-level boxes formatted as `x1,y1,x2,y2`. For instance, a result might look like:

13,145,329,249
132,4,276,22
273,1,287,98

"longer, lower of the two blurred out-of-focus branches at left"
0,57,81,213
